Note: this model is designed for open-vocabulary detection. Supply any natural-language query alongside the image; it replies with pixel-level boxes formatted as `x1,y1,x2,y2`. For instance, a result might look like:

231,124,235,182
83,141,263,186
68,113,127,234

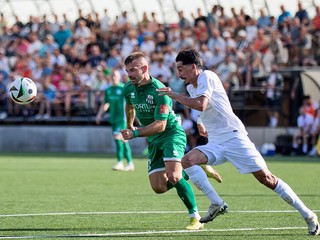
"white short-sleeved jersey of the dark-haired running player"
187,70,248,144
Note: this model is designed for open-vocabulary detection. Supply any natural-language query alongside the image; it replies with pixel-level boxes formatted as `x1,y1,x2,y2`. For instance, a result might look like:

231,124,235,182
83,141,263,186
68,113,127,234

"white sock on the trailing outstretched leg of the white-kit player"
274,178,312,218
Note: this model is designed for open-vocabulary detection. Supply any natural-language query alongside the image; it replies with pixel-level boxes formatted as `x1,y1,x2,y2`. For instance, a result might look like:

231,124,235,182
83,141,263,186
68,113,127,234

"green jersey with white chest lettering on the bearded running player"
124,78,185,143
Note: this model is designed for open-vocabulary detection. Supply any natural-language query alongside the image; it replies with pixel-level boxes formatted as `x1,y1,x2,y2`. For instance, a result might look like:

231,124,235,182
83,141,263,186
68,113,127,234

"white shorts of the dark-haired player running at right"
196,136,267,174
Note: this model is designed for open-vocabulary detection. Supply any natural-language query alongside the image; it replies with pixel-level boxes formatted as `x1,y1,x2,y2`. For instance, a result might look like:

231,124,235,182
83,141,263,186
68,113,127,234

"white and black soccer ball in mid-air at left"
9,77,37,104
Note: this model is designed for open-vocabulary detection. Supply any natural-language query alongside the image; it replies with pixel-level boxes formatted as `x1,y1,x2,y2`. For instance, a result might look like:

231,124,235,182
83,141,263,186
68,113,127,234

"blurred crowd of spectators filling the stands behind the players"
0,2,320,136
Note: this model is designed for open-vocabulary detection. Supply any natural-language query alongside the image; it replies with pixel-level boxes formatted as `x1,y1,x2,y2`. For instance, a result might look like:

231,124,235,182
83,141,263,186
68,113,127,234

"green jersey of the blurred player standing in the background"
104,83,126,124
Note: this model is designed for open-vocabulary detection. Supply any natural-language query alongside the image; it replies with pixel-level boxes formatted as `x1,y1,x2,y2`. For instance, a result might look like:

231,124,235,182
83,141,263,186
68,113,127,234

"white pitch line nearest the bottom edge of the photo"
0,227,306,239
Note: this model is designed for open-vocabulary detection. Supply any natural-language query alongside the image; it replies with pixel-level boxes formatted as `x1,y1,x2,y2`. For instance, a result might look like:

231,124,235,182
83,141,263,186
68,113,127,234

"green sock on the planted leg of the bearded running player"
174,178,198,214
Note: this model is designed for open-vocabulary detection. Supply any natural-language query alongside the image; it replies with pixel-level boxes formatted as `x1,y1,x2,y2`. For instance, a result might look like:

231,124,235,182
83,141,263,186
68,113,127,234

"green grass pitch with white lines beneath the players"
0,153,320,240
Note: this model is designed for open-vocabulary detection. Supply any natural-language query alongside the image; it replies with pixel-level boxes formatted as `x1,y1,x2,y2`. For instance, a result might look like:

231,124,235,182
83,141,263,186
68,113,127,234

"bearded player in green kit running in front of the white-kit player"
121,52,220,230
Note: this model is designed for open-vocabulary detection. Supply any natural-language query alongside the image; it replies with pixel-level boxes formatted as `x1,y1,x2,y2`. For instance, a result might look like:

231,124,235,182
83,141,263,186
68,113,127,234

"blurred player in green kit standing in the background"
96,70,134,171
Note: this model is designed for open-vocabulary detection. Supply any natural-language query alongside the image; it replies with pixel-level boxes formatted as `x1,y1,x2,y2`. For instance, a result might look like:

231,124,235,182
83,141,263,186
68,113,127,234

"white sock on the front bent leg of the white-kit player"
184,165,223,205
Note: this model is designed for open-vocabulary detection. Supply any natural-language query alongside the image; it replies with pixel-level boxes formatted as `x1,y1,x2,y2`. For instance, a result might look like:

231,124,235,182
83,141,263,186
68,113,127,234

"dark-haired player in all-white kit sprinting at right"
158,49,320,235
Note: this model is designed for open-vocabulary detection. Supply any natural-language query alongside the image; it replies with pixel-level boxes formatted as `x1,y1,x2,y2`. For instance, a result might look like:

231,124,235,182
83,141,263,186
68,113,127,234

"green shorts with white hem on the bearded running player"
148,134,186,175
